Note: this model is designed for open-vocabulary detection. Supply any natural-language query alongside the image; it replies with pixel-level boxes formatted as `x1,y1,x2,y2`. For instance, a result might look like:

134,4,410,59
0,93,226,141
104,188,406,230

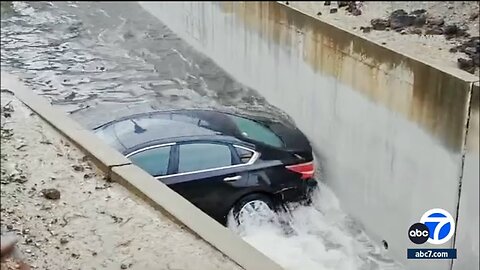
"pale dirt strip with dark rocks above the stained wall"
281,1,480,76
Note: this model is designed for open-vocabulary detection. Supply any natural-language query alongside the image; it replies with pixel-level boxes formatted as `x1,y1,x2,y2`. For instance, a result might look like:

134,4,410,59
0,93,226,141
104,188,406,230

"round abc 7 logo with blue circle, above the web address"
408,208,455,245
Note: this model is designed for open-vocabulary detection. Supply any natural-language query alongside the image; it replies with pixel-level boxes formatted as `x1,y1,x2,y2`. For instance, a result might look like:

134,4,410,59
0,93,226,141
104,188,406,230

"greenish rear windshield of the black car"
230,115,284,147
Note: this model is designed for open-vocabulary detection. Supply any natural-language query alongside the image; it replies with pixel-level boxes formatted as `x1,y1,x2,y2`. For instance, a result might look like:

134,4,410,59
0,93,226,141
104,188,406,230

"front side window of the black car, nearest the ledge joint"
129,146,171,176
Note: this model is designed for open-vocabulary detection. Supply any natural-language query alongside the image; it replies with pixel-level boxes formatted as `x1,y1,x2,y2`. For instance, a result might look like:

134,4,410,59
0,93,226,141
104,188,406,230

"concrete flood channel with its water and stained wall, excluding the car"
1,2,479,270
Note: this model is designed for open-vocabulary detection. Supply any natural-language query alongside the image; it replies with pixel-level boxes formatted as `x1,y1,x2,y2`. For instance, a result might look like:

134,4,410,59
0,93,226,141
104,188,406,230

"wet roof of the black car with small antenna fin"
95,110,250,151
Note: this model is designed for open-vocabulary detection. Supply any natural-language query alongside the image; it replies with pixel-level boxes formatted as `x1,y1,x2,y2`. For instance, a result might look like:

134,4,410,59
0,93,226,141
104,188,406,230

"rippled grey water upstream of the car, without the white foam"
1,2,283,126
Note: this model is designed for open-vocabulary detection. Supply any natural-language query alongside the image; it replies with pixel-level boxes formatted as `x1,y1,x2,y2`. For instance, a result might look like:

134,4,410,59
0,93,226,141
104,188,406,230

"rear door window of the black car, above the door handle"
178,143,232,173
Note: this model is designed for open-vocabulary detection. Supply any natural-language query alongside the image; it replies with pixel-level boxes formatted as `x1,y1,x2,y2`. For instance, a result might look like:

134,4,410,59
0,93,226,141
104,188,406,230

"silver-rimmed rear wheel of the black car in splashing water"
232,193,275,225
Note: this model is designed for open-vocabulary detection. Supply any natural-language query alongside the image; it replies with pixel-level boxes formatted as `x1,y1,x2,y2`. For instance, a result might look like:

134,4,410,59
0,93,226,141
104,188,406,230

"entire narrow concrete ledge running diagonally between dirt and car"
1,72,282,270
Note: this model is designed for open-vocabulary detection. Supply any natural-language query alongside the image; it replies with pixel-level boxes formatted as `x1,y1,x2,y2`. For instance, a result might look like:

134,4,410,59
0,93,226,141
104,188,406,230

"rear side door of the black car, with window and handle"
161,141,248,220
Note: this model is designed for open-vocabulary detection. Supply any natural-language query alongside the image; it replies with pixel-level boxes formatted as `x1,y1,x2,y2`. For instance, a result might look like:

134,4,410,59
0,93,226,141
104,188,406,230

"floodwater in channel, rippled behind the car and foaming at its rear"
1,2,404,270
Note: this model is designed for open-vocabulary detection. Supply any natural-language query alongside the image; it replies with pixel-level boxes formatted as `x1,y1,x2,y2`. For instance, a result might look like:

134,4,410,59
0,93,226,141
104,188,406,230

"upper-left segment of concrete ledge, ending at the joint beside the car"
1,72,131,175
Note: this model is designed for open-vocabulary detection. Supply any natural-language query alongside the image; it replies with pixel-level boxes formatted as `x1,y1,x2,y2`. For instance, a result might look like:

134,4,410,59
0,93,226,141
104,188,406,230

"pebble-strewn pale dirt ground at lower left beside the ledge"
1,89,240,270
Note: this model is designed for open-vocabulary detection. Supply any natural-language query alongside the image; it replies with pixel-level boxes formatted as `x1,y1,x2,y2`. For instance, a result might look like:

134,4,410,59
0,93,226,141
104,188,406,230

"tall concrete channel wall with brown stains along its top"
137,2,478,270
